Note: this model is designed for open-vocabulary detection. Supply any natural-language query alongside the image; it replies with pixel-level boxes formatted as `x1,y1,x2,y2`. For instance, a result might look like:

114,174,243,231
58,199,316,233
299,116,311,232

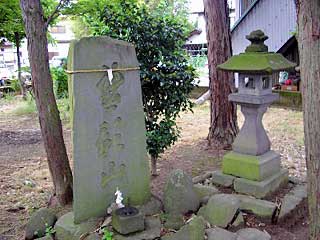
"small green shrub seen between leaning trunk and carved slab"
51,67,68,99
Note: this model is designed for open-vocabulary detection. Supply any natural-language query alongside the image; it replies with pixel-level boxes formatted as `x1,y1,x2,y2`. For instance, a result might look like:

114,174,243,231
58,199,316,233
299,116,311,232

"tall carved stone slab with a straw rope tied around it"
68,37,150,223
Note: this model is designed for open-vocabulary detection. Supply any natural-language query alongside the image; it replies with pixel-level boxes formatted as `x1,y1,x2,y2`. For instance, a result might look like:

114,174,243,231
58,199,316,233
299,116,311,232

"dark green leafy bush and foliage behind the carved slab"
72,0,195,157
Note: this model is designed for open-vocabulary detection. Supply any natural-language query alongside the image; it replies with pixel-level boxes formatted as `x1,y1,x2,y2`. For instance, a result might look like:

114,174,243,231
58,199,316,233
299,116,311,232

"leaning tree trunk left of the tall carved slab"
20,0,72,205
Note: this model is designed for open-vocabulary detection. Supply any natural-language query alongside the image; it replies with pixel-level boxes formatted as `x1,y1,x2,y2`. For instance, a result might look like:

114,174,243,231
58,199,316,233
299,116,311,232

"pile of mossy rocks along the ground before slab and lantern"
26,170,307,240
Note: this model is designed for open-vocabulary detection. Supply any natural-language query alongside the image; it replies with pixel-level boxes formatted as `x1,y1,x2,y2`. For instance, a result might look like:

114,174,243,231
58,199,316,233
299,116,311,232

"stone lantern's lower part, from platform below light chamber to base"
222,93,288,198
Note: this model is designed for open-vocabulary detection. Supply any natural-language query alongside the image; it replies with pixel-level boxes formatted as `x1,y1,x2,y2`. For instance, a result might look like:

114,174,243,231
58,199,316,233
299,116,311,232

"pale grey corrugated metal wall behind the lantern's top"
232,0,296,54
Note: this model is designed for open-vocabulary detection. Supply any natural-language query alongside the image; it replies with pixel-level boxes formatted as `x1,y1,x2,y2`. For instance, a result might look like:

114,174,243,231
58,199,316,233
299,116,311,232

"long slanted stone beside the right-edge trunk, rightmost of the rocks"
279,185,308,218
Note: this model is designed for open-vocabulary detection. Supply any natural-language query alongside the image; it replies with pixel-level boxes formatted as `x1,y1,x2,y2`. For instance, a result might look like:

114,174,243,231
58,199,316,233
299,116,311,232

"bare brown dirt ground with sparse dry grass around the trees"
0,99,307,240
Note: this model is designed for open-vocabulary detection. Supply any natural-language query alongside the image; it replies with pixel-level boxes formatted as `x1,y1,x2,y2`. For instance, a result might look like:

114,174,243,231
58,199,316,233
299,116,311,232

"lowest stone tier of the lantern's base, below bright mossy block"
233,169,289,198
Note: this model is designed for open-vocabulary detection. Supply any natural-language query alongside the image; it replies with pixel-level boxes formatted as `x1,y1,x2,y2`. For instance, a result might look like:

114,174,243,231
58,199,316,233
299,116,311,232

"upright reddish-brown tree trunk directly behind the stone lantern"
204,0,238,148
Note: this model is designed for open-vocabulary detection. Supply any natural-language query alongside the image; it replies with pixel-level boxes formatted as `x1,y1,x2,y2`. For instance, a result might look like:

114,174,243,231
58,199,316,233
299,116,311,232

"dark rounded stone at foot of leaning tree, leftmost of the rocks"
25,208,57,239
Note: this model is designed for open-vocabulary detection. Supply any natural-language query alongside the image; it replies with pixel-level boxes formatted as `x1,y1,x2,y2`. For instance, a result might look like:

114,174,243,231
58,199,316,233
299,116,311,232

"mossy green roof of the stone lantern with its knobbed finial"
218,30,296,74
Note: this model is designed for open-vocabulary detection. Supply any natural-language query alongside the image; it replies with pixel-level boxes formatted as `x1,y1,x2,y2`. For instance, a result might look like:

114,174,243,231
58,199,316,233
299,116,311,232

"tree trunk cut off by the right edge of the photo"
297,0,320,240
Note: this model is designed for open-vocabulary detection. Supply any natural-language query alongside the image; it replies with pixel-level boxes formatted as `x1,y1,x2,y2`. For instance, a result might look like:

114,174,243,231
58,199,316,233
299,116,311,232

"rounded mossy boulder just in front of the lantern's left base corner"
198,194,240,228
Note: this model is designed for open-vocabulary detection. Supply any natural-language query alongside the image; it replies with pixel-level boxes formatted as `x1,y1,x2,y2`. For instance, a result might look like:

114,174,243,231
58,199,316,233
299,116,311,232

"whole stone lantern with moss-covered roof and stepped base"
218,30,295,198
